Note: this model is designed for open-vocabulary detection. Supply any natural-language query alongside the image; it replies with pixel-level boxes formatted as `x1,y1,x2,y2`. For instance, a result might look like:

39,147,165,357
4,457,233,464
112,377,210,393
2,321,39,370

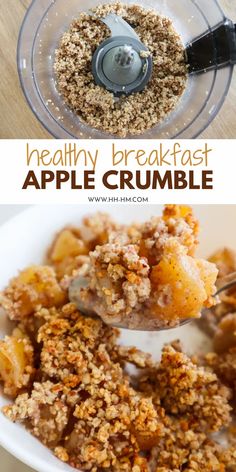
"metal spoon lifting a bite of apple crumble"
69,272,236,331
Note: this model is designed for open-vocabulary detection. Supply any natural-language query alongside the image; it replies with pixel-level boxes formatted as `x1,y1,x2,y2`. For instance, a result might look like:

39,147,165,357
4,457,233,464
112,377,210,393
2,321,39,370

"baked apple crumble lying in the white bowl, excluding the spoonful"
0,206,236,472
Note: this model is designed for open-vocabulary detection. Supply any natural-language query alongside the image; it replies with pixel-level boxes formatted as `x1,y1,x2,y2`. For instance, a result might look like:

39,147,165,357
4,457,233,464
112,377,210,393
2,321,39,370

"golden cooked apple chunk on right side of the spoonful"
150,247,217,322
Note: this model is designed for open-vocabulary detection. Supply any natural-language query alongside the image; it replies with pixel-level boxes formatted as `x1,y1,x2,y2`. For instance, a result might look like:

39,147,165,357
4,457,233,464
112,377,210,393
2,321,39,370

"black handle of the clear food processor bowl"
186,19,236,74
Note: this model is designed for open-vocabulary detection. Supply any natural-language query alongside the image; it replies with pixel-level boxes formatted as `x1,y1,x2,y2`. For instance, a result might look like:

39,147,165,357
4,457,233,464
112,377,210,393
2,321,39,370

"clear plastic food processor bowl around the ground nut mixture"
17,0,233,139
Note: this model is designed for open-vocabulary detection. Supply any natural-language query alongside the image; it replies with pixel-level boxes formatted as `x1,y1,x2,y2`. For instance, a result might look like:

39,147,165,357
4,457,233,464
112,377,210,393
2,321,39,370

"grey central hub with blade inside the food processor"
92,13,152,96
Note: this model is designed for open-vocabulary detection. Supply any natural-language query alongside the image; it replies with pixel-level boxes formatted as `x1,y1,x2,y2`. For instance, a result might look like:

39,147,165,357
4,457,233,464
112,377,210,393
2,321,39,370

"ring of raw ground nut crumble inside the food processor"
54,2,187,137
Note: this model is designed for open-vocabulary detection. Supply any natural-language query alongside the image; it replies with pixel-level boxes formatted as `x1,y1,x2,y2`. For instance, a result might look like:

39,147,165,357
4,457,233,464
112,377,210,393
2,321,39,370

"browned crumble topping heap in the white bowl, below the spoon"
3,304,236,472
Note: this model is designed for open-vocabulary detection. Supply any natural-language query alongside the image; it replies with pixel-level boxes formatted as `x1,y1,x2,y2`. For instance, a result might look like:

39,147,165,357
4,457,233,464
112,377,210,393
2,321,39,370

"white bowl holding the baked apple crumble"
0,205,236,472
